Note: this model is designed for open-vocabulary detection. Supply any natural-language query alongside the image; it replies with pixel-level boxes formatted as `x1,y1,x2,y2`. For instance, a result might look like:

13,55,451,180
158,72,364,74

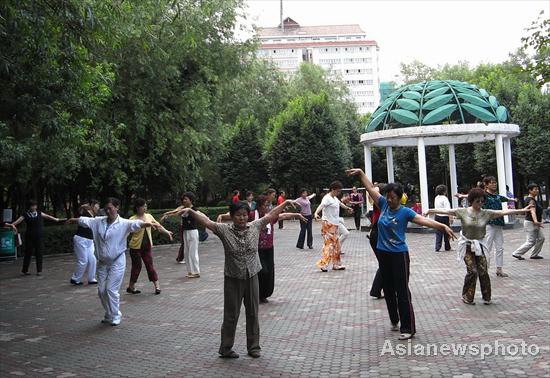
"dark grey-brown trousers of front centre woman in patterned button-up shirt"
219,275,261,355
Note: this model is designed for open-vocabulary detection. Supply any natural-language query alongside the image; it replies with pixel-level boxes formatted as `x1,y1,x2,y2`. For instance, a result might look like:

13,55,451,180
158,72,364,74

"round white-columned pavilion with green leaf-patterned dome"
361,80,520,216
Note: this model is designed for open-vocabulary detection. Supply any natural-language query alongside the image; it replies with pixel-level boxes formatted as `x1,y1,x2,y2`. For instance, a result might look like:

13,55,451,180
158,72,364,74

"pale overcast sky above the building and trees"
246,0,550,81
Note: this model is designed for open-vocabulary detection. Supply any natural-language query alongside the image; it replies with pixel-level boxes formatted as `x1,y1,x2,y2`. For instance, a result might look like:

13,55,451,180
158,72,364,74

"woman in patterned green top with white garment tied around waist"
425,188,529,305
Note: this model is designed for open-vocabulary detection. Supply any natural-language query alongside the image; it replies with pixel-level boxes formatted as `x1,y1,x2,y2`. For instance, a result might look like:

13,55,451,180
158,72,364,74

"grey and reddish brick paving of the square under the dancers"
0,222,550,377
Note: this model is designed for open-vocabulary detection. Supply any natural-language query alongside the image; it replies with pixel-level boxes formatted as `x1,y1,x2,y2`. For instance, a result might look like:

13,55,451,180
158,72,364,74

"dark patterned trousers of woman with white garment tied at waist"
462,246,491,302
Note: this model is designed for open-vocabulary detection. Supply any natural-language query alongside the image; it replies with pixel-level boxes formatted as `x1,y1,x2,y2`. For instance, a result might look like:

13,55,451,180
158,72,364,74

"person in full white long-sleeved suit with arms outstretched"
68,198,157,326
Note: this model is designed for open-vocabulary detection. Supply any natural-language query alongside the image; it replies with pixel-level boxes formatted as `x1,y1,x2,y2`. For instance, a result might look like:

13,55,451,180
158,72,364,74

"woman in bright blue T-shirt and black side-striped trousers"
347,169,455,340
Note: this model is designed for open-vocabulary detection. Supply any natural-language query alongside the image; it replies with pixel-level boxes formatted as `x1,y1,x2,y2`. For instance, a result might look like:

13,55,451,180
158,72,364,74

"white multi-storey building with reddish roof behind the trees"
258,17,380,114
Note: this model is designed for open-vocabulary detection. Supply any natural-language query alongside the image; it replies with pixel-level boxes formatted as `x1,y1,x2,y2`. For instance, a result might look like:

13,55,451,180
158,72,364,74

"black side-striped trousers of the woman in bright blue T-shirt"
378,251,416,334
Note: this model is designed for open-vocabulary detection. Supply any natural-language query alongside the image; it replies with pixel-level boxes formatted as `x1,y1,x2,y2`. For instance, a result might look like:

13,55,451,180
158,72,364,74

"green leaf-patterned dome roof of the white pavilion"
366,80,508,132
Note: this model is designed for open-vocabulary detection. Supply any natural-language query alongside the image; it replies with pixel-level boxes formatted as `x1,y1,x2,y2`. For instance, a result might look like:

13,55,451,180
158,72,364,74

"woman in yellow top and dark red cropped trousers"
126,198,172,294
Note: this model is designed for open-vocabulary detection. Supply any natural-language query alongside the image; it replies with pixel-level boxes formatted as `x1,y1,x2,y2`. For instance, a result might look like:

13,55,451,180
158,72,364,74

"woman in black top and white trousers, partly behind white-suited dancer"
70,200,99,286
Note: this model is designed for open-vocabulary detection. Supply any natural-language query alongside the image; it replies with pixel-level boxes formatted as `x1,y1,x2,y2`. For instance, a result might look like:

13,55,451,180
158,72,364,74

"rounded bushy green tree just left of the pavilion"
267,91,350,194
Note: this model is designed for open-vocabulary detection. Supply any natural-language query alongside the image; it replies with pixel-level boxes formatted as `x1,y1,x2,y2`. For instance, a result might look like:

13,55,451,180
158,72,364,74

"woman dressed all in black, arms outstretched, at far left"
8,200,60,276
